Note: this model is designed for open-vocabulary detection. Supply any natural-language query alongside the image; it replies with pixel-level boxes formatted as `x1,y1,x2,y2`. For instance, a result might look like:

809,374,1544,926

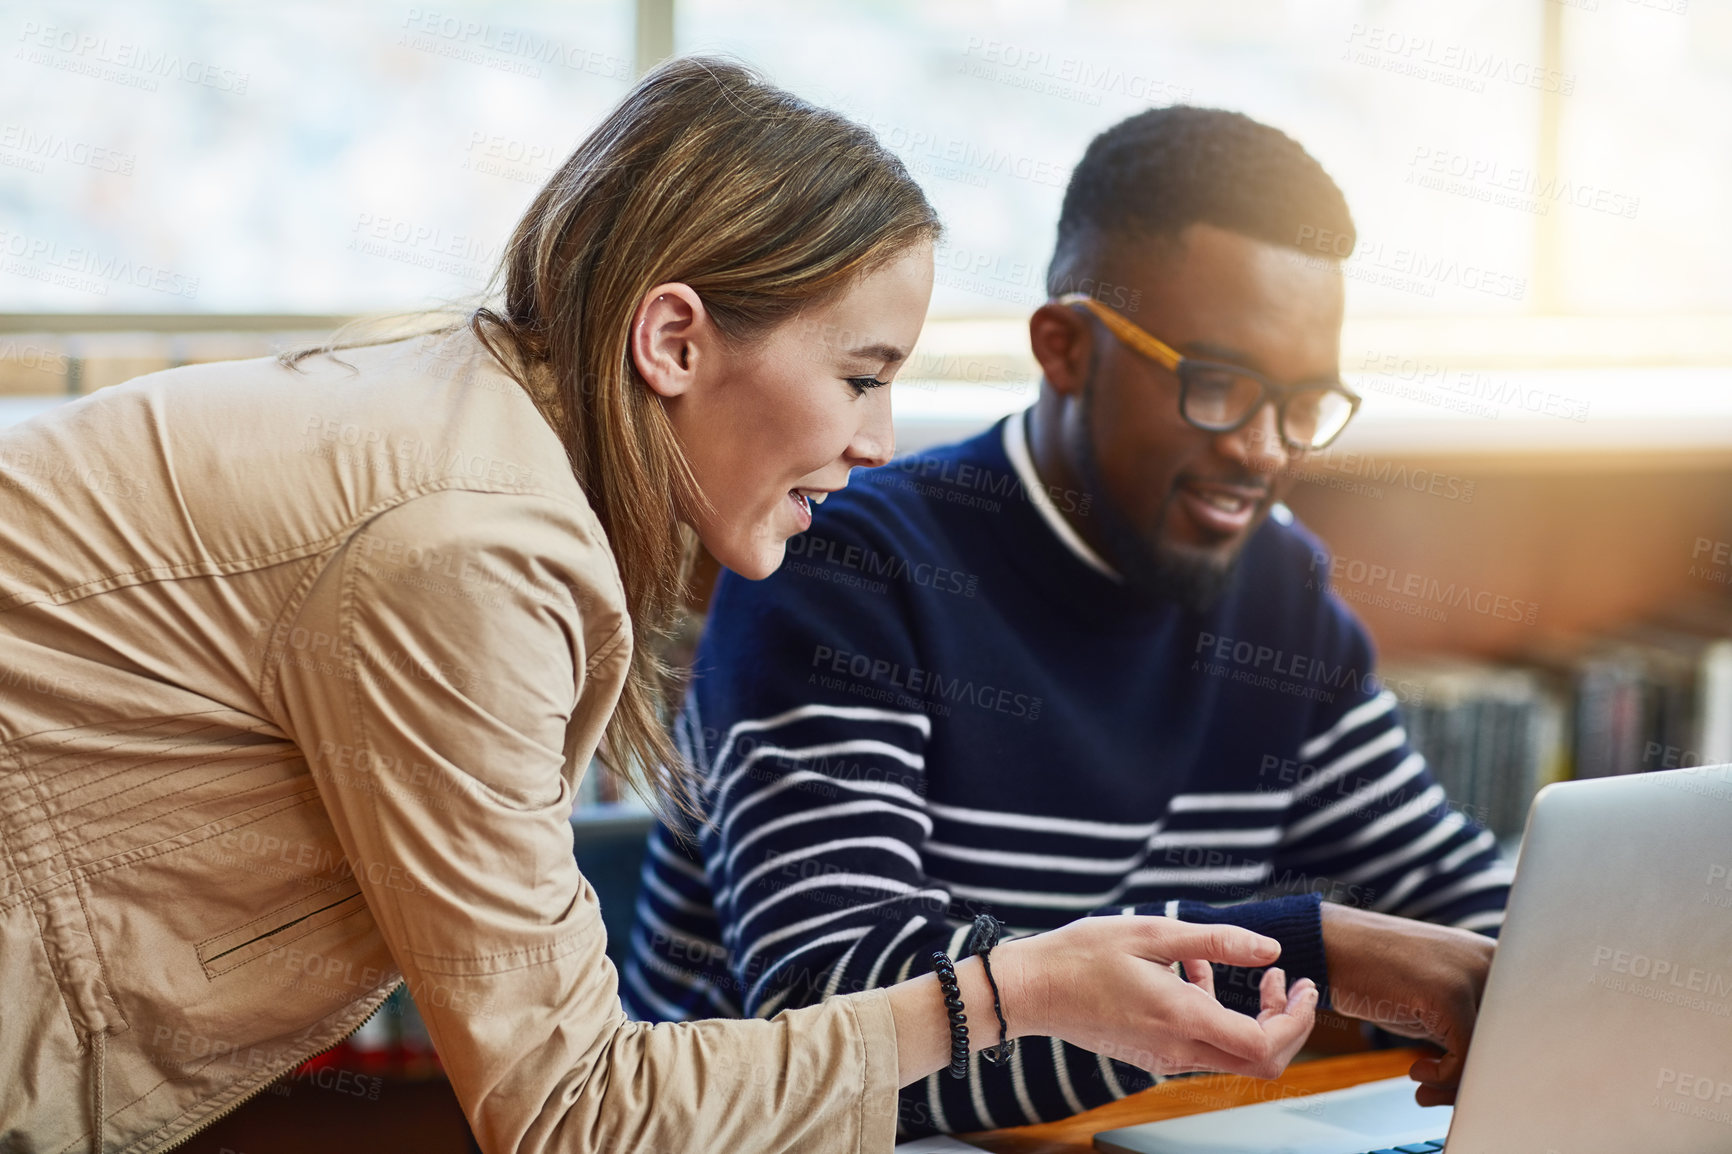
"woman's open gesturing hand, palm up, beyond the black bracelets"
992,915,1316,1078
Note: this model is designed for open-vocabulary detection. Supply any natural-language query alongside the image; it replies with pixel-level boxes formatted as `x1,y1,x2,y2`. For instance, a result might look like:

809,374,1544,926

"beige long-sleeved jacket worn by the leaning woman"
0,334,897,1154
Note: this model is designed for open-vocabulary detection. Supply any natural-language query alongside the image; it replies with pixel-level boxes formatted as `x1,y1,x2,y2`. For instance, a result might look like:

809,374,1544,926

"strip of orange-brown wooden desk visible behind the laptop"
956,1050,1420,1154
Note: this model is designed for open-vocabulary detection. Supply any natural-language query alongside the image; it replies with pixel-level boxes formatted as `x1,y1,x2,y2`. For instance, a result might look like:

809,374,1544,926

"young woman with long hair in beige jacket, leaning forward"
0,61,1315,1154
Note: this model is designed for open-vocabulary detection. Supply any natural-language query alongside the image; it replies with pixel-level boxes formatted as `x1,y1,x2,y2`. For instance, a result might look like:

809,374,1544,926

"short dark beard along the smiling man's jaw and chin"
1067,376,1242,613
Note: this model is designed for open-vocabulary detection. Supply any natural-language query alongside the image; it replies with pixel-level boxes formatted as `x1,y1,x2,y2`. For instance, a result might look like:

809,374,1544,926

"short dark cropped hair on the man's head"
1046,104,1356,296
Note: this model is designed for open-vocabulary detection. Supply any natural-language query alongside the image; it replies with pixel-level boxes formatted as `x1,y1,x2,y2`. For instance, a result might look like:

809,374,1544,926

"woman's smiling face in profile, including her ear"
630,241,932,580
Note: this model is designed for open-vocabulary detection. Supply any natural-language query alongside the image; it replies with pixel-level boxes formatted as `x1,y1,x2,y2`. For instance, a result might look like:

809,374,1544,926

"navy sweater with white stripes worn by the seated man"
622,416,1509,1137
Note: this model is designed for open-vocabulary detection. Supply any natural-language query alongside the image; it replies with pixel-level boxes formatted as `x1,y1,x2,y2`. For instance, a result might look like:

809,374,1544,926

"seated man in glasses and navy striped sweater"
624,107,1509,1135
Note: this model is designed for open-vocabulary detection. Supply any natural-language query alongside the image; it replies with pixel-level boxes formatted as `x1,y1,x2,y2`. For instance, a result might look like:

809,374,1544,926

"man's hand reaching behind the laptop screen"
1323,901,1496,1105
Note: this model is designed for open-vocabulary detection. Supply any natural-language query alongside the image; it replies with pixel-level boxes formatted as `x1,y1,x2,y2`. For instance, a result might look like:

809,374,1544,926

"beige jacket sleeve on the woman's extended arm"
277,490,897,1154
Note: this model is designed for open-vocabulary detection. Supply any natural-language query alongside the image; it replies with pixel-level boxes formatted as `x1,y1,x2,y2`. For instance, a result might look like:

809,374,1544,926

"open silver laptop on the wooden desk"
1095,766,1732,1154
